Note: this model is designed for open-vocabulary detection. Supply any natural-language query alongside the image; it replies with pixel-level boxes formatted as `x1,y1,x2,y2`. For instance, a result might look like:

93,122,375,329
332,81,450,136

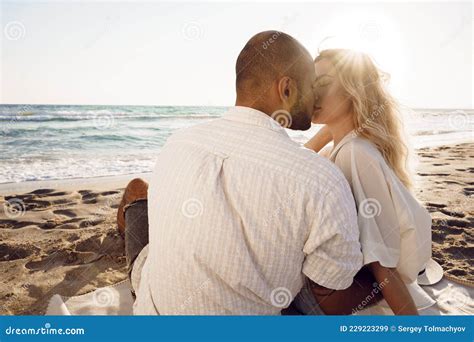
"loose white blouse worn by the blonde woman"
321,131,435,309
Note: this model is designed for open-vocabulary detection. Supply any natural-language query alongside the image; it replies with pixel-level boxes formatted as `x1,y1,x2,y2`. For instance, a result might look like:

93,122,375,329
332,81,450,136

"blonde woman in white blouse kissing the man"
305,49,435,315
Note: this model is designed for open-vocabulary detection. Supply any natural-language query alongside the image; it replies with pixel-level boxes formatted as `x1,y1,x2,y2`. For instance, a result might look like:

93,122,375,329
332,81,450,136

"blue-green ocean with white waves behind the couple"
0,105,474,184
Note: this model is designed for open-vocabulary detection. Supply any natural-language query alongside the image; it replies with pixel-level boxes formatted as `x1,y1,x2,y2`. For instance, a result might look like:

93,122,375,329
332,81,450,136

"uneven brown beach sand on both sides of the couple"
0,143,474,315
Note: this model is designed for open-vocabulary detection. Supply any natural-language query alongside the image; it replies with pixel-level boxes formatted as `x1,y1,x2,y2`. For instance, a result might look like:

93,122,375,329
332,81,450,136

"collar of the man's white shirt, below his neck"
223,106,288,136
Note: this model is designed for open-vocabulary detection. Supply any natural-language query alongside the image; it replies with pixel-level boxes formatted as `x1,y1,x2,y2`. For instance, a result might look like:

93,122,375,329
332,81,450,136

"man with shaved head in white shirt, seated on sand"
118,31,382,315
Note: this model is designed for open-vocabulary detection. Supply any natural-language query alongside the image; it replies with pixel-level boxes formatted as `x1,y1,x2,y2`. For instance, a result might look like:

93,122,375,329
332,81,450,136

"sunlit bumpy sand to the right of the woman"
416,143,474,281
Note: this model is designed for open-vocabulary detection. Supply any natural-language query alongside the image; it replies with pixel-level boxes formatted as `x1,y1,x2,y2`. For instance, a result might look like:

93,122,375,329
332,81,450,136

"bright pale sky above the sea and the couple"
0,0,474,108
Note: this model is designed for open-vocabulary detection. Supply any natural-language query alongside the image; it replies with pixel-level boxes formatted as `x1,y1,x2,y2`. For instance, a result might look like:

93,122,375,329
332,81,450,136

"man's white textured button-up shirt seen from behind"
134,107,362,315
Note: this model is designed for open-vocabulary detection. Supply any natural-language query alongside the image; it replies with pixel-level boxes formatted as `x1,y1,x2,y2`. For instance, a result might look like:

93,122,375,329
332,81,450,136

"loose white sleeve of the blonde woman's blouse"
336,144,401,268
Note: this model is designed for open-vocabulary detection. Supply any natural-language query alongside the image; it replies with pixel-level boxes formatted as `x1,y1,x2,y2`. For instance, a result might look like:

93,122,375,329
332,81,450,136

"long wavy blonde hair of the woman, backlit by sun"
315,49,412,189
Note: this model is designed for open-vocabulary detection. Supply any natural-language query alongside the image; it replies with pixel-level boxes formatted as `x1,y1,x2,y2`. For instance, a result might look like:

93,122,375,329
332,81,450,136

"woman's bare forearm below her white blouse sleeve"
368,262,418,315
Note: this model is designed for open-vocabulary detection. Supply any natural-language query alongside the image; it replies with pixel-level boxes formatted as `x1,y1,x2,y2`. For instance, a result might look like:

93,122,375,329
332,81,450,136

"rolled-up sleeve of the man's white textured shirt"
303,179,362,290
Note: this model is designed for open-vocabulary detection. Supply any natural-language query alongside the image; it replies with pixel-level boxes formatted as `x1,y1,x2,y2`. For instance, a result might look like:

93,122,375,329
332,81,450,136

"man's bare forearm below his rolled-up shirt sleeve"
311,268,383,315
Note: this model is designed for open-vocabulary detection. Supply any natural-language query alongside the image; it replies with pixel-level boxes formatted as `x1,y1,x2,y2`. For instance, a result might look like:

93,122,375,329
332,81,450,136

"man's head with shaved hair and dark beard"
235,31,316,130
